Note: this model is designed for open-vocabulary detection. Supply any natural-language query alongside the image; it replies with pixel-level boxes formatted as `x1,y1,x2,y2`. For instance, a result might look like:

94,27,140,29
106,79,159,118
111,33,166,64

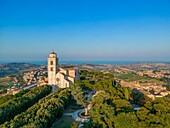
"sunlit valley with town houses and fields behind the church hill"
0,54,170,99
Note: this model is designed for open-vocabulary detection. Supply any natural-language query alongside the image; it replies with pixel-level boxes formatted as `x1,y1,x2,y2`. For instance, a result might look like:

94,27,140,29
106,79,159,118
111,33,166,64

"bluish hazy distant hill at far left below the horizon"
0,63,39,77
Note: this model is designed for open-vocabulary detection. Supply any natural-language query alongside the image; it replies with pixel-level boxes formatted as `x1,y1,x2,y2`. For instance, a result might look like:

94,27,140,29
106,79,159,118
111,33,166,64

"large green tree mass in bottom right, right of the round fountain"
85,91,170,128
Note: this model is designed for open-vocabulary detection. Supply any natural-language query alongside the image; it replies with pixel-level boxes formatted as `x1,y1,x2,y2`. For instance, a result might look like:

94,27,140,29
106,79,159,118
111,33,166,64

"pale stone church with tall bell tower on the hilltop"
48,52,80,88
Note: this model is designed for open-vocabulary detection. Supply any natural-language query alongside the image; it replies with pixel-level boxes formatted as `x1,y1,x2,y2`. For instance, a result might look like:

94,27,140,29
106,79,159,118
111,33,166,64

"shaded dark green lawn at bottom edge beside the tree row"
51,116,73,128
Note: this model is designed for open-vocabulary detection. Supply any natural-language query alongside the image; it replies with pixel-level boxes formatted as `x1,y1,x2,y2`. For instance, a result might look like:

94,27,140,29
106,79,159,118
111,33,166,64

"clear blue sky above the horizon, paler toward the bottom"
0,0,170,61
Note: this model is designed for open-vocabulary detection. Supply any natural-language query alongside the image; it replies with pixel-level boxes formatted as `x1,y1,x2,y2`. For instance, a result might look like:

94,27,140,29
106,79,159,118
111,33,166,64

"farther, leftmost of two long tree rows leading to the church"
0,85,52,124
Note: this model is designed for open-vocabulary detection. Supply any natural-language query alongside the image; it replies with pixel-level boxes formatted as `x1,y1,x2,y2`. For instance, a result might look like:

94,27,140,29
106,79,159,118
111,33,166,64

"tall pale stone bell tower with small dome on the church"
48,52,58,85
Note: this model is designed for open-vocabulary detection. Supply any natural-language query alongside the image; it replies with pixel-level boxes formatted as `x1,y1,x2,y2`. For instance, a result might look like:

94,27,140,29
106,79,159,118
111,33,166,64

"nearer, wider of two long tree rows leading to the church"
0,89,71,128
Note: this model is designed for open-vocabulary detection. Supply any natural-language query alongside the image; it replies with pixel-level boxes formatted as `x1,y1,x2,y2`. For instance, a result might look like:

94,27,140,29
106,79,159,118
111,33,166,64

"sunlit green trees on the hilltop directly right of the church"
79,70,131,100
